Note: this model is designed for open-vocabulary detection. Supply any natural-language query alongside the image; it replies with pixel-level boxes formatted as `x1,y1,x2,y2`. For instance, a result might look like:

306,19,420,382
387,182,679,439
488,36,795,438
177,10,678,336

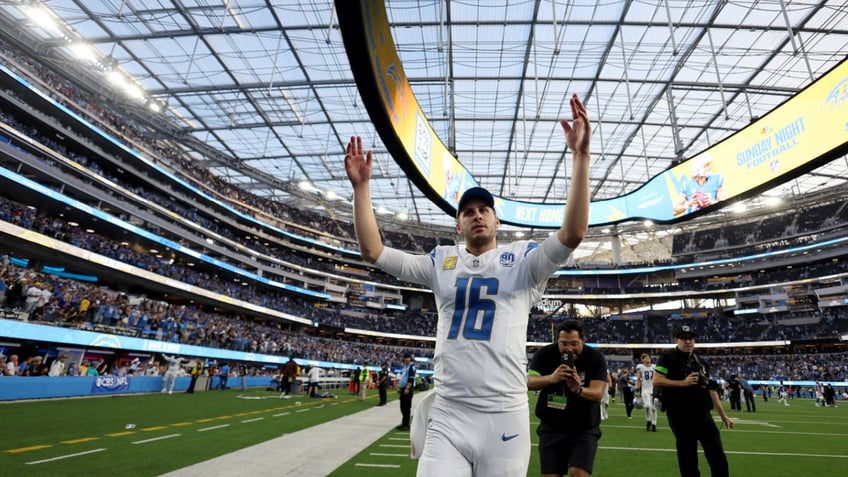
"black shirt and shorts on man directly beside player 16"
530,343,607,474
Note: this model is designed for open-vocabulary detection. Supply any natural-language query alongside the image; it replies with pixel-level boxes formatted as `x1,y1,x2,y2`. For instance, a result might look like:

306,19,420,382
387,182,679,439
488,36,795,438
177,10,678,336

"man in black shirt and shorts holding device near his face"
527,321,608,477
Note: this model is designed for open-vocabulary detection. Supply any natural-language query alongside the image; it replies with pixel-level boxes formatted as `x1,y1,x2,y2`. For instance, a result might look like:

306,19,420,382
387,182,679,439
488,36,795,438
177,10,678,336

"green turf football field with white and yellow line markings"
0,388,848,477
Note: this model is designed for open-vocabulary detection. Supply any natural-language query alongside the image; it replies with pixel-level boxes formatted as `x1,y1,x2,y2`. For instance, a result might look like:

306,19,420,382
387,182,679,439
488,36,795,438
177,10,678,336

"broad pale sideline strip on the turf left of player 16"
163,389,433,477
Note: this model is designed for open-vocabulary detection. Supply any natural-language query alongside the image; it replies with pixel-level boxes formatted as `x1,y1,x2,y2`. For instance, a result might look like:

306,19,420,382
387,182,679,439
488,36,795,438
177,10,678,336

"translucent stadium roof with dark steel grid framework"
0,0,848,261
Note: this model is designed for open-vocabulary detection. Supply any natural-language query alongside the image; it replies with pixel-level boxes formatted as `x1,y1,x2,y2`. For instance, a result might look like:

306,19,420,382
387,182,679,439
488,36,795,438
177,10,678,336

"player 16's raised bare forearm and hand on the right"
557,94,592,248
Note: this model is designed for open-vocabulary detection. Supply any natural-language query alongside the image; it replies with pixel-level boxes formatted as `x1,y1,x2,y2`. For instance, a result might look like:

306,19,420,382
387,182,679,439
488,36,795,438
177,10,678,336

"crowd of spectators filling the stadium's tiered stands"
0,35,848,388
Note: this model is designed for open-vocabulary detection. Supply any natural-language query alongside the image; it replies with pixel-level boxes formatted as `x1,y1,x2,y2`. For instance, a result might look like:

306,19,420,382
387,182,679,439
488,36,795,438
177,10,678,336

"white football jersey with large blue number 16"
377,235,571,412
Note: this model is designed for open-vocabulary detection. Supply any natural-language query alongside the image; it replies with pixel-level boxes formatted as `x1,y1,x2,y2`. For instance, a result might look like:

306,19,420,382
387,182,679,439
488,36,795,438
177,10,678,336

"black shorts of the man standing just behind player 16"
536,423,601,475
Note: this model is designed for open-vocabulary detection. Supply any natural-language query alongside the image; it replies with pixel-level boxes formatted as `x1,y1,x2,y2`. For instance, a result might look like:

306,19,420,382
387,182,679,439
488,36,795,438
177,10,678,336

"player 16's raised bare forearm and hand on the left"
345,136,383,263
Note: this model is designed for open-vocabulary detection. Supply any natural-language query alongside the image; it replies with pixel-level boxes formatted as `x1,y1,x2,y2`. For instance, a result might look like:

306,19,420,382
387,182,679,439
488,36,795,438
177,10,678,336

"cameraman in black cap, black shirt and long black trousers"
654,325,734,477
